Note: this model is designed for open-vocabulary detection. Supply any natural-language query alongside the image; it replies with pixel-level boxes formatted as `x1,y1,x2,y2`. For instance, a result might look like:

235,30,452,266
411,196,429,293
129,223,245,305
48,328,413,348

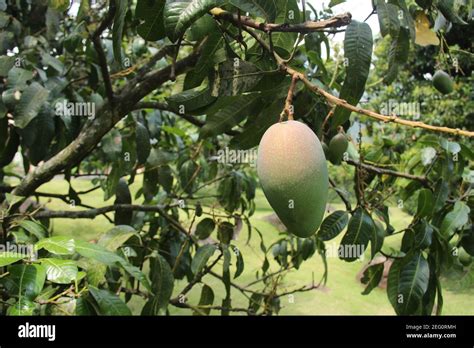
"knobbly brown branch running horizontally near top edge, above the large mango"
210,7,352,33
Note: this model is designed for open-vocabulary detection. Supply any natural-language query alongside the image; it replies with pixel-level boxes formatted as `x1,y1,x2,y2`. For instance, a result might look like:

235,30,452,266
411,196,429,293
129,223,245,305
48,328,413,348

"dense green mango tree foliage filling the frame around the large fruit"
0,0,474,315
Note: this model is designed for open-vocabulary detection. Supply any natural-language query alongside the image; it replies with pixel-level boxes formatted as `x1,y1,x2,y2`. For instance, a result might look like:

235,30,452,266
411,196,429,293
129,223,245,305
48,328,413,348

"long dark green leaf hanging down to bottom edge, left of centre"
142,254,174,315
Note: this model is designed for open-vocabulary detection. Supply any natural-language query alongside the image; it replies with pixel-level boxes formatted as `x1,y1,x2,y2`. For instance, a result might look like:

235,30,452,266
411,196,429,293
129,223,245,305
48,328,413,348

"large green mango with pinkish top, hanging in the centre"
257,120,329,238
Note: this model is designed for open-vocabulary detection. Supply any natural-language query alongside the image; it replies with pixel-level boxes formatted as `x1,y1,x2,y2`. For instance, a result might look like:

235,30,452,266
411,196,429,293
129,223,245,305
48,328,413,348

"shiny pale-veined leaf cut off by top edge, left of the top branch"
164,0,221,42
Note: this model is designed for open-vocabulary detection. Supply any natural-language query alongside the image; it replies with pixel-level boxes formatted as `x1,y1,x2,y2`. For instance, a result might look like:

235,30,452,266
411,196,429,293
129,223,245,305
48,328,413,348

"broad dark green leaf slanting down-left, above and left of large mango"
199,94,259,138
